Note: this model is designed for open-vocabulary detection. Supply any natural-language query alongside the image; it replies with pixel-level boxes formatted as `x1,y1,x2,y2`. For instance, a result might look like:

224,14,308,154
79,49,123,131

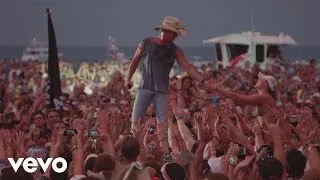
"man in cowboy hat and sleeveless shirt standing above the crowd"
125,16,204,134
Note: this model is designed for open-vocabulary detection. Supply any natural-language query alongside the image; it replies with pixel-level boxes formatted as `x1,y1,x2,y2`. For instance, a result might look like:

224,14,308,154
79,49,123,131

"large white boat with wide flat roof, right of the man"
202,31,297,69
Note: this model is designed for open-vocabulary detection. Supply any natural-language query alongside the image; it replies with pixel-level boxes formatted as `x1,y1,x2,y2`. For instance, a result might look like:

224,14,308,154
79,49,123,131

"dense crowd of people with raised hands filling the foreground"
0,56,320,180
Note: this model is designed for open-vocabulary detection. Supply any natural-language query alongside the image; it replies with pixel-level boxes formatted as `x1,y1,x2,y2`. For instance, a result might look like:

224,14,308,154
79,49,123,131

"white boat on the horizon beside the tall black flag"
21,38,63,62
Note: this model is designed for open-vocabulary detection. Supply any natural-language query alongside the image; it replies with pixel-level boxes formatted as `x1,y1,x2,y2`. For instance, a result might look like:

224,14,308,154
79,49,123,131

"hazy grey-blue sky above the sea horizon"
0,0,320,46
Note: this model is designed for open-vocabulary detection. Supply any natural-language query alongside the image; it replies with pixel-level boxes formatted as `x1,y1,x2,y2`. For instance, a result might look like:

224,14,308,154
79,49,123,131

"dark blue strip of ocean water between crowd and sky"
0,46,320,64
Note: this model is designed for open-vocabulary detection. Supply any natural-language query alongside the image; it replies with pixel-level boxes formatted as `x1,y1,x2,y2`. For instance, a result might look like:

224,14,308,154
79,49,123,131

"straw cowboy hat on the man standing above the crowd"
154,16,187,36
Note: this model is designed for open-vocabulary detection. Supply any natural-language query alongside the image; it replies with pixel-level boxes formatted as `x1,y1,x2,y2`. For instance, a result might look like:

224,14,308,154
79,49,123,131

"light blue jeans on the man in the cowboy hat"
132,89,168,123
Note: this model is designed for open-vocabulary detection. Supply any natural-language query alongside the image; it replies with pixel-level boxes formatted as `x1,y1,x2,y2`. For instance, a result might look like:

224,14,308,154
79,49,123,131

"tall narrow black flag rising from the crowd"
47,9,62,111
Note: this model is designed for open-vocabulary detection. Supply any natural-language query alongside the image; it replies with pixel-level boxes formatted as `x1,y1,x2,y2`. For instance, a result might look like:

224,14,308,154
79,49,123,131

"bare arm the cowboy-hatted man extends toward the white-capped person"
176,48,204,81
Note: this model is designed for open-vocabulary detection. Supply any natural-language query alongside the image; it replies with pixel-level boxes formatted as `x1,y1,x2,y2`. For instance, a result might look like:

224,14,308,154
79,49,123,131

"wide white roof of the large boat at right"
202,32,297,45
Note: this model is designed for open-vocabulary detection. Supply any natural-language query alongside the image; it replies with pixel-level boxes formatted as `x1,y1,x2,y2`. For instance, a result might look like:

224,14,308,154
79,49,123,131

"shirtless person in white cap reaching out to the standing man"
204,73,278,115
